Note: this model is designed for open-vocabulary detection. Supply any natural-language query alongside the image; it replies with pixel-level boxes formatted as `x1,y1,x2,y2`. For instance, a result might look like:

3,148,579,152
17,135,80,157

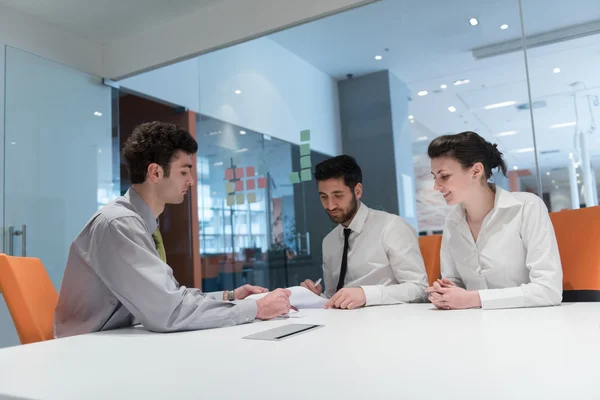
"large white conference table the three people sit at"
0,303,600,400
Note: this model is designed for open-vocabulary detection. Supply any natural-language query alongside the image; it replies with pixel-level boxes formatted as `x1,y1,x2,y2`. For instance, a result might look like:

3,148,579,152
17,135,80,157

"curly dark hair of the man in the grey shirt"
123,121,198,184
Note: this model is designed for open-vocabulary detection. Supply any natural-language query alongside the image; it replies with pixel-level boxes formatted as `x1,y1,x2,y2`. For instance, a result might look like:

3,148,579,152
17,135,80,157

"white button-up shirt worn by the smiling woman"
440,187,562,308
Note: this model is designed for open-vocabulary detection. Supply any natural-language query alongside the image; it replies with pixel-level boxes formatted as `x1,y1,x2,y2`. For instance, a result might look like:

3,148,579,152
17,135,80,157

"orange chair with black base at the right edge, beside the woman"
550,207,600,302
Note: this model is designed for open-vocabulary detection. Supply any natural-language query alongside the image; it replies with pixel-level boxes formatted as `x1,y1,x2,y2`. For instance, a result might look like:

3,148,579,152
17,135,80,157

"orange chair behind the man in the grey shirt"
0,254,58,344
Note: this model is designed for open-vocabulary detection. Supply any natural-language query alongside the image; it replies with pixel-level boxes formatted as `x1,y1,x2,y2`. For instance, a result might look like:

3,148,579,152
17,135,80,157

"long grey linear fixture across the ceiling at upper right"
471,20,600,60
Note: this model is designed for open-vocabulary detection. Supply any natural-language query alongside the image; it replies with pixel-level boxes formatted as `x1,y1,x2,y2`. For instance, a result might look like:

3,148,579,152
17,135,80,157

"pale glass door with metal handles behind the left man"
0,46,119,347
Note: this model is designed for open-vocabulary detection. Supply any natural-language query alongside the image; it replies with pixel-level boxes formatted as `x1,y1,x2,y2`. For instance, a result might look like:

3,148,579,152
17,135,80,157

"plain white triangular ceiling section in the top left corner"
0,0,222,43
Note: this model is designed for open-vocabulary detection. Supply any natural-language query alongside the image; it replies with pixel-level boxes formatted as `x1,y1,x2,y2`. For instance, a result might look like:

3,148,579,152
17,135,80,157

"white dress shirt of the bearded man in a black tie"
323,203,427,306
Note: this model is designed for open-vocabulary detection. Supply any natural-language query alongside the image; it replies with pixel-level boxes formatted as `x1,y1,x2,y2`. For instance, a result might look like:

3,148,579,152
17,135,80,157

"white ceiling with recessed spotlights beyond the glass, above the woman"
271,0,600,192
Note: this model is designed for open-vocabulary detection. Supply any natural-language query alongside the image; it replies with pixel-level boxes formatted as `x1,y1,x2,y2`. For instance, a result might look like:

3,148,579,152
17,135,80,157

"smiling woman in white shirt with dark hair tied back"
427,132,562,310
